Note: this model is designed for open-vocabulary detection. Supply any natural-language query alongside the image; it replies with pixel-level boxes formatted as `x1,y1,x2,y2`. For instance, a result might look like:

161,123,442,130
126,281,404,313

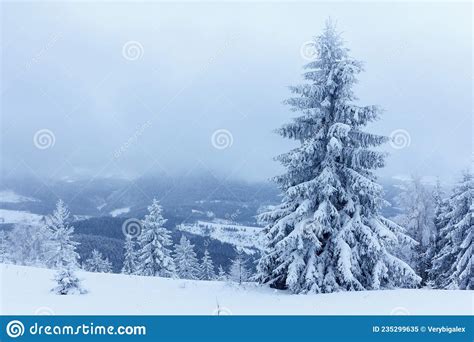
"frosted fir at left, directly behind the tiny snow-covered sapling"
46,200,79,269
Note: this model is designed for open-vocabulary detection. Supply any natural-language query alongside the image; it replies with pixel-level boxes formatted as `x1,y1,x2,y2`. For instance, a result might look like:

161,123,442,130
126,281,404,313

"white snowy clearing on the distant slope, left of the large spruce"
177,220,263,254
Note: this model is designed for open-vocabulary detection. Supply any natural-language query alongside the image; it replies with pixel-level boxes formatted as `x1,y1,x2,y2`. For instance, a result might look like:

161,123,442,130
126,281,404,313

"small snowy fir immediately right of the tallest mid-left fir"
174,235,200,279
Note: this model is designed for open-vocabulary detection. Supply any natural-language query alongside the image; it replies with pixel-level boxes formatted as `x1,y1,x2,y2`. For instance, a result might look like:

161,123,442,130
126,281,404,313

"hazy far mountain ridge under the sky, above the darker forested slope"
0,173,418,224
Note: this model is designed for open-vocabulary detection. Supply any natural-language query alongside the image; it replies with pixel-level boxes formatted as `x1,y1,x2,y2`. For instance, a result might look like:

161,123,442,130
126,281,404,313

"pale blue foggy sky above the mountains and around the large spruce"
1,2,472,181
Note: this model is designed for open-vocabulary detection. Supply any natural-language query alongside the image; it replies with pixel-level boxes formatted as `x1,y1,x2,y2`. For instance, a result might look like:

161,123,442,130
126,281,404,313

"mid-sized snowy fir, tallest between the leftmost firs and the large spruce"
136,199,175,277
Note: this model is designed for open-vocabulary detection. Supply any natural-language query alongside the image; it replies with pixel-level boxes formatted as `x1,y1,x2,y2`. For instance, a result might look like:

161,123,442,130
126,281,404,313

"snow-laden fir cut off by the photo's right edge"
430,172,474,290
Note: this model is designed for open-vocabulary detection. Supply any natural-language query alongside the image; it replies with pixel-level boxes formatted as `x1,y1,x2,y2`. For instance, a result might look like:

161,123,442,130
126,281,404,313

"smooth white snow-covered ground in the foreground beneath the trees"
0,265,474,315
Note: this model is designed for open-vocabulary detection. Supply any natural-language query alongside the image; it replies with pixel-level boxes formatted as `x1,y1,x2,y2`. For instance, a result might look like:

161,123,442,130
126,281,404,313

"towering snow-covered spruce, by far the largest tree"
257,22,420,293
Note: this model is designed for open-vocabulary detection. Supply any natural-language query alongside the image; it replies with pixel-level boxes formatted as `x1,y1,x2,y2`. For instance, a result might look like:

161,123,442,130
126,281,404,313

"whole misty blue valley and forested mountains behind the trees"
0,174,432,272
